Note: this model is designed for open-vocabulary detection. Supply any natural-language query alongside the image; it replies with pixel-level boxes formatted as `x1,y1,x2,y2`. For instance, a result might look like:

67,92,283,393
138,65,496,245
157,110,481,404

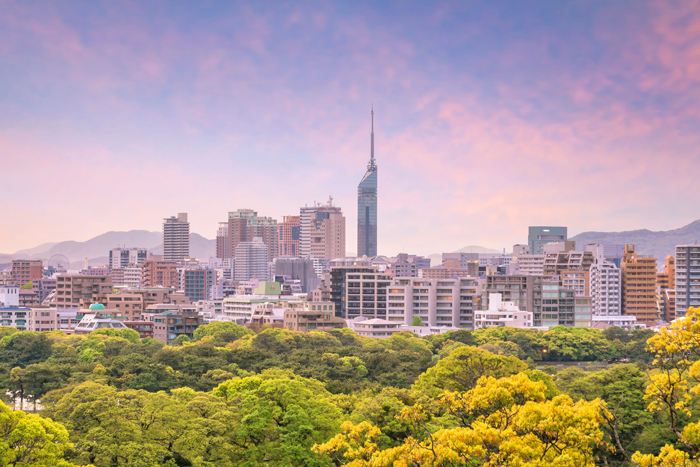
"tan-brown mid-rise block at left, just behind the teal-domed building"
56,274,114,310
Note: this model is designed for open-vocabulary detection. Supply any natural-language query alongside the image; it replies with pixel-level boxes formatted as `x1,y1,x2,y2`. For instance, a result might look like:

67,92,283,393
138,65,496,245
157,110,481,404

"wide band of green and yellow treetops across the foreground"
0,309,700,467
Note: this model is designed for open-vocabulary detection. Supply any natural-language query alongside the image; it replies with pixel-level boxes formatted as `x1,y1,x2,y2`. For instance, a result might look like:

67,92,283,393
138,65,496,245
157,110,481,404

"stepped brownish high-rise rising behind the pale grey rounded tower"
226,209,279,261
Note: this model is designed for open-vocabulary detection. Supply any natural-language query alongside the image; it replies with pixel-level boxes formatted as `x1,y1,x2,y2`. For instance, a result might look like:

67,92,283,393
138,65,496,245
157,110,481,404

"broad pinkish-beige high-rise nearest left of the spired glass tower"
299,197,345,260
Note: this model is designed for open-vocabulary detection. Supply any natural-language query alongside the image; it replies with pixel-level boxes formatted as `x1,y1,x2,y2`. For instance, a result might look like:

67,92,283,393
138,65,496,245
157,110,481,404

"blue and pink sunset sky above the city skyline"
0,0,700,255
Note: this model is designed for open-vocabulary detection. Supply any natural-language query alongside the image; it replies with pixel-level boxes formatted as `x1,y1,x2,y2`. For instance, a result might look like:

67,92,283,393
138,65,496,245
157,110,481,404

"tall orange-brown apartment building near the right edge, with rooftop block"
620,245,659,325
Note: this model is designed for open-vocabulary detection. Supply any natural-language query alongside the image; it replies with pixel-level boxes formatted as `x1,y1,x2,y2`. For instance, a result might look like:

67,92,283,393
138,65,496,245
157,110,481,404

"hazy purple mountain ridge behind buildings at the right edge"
569,220,700,263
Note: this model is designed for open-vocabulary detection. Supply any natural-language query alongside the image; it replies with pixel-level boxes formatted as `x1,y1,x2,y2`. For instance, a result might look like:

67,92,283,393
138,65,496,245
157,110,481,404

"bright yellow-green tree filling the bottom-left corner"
0,401,73,467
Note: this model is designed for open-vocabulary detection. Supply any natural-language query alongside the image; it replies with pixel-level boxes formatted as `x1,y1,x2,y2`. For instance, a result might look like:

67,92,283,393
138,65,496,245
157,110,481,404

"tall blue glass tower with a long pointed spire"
357,108,377,256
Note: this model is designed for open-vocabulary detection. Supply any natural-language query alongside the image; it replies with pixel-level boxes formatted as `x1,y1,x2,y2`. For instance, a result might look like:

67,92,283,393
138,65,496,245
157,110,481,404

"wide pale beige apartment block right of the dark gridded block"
382,275,482,329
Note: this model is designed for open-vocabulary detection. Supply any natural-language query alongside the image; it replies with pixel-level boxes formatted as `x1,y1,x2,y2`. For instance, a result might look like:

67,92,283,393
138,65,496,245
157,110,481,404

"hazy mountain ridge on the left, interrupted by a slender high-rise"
0,230,216,269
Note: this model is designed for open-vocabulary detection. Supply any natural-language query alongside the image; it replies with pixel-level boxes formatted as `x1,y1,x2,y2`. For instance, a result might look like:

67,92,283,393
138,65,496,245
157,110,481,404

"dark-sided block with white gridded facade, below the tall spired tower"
330,266,392,319
